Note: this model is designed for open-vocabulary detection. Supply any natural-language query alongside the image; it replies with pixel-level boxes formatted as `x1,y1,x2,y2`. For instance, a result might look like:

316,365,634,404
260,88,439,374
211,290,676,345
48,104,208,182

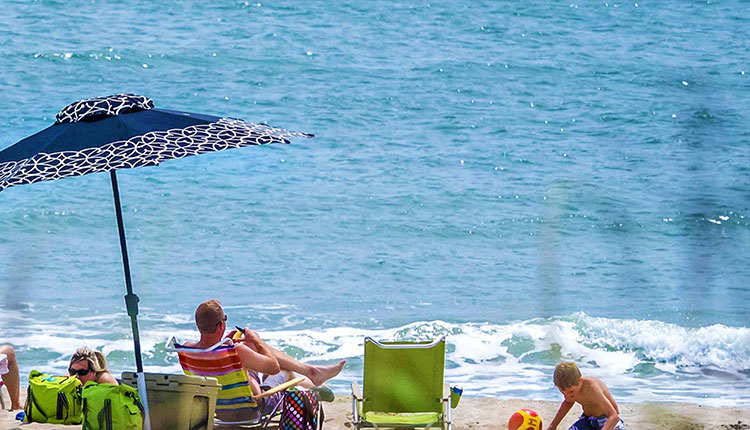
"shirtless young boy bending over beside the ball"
547,362,625,430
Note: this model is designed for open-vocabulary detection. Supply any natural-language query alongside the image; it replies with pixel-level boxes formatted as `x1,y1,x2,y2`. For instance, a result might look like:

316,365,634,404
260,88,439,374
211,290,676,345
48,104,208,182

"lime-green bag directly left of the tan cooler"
81,381,143,430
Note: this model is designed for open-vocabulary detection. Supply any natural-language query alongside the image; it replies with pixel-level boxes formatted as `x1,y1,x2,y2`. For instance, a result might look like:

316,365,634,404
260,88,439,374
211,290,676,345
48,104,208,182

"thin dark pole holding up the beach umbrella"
109,170,151,430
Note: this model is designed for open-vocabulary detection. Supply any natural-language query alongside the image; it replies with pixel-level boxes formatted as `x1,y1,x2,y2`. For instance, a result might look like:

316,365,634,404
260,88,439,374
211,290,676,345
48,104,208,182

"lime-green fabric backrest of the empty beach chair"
362,337,445,413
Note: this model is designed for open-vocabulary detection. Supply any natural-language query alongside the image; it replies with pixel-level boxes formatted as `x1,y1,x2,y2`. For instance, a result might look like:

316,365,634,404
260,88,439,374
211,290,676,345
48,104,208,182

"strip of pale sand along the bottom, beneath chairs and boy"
0,393,750,430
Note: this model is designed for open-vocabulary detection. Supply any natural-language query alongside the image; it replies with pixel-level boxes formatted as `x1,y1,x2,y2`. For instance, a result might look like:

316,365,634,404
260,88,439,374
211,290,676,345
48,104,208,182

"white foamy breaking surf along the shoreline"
4,313,750,406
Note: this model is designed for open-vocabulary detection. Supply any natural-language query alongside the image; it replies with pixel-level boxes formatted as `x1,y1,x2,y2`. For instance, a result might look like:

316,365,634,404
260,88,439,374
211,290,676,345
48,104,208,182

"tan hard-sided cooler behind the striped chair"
122,372,221,430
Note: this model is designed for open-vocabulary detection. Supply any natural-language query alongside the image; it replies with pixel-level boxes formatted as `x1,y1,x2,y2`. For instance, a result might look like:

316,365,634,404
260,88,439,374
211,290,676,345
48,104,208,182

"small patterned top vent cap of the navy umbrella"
55,94,154,124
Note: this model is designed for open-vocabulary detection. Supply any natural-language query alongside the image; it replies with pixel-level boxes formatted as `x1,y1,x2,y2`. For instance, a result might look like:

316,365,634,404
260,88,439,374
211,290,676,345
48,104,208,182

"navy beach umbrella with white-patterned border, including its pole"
0,94,312,423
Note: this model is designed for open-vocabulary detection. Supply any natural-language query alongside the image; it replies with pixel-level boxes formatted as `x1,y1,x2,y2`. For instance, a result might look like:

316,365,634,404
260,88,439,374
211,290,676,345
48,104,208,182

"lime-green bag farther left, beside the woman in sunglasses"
24,370,82,424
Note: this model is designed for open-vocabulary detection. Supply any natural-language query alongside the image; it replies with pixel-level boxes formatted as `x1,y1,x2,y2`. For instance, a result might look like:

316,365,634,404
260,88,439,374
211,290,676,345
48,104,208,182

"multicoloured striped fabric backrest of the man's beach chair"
174,343,258,416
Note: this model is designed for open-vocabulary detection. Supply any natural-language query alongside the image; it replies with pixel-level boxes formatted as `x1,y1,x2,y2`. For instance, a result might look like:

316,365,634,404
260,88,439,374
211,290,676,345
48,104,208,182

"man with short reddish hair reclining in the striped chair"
184,300,346,413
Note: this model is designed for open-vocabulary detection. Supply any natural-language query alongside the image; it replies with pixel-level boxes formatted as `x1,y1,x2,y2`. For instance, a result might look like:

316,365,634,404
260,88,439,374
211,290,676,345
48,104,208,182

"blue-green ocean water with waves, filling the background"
0,0,750,407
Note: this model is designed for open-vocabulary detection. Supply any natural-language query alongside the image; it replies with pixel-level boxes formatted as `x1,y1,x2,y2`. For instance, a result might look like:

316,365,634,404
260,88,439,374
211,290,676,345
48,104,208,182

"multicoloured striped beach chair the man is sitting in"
166,337,304,428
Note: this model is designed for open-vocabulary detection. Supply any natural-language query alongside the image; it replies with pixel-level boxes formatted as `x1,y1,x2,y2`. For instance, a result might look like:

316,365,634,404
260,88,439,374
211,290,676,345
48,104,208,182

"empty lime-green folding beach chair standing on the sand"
352,337,451,430
